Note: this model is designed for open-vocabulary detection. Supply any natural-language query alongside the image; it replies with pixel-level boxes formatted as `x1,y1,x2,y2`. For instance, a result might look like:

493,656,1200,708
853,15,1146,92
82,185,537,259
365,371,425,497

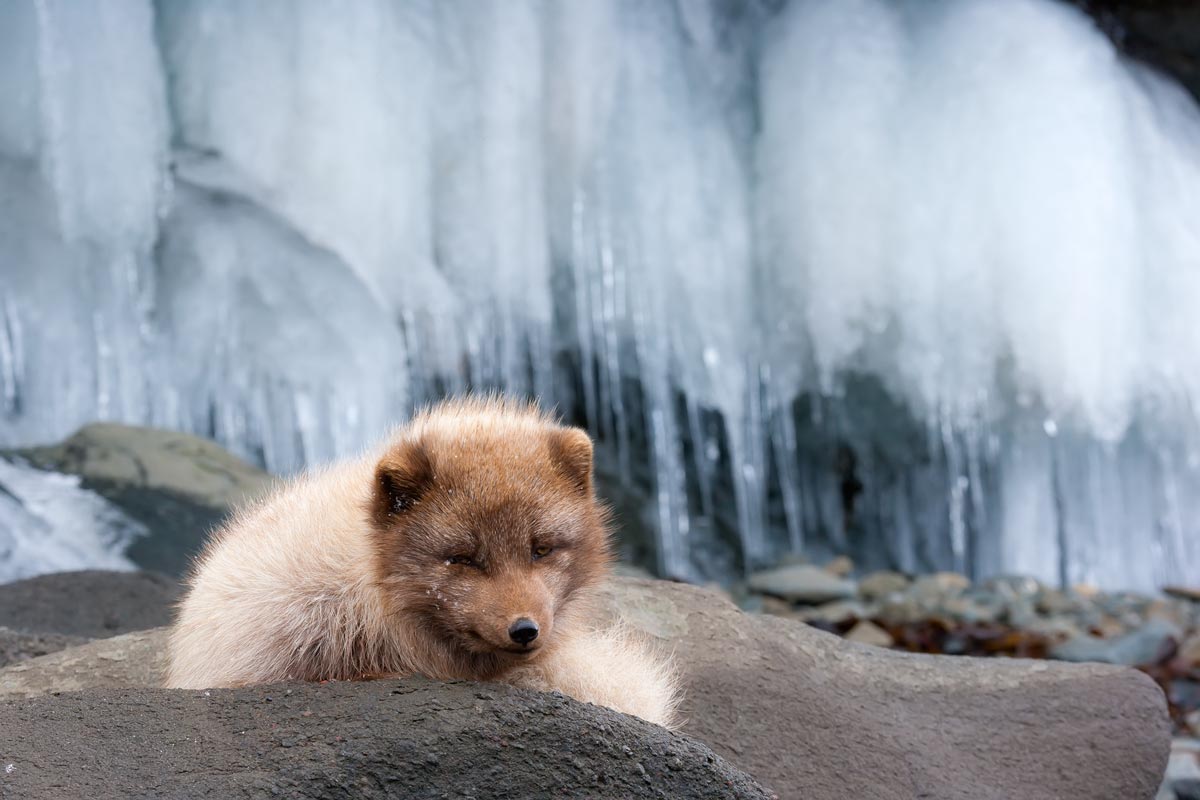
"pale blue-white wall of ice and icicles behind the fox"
0,0,1200,588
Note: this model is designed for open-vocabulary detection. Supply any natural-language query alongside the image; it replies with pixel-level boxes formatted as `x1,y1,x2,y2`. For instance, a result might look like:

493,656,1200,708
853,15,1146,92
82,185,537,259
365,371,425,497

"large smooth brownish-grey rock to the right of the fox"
600,579,1170,800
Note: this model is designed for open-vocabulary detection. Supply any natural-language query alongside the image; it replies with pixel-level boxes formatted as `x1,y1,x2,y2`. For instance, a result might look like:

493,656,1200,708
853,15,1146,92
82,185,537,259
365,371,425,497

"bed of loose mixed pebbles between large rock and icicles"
734,558,1200,738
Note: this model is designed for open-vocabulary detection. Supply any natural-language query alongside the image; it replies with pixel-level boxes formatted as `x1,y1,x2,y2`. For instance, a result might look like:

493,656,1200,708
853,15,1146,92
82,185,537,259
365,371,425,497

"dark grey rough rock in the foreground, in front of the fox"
0,679,772,800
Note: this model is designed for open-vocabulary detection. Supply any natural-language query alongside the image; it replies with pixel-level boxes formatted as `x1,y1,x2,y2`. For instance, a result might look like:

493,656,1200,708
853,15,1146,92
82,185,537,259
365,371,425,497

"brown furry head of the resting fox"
371,399,611,676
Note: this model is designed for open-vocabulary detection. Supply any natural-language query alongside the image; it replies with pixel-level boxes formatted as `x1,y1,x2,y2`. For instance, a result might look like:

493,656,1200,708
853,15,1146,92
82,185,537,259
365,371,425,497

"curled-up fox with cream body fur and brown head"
166,398,677,726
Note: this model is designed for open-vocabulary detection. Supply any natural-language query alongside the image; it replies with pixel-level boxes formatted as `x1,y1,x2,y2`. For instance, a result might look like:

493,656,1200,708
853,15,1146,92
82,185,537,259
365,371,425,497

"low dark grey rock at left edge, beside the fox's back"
0,570,180,638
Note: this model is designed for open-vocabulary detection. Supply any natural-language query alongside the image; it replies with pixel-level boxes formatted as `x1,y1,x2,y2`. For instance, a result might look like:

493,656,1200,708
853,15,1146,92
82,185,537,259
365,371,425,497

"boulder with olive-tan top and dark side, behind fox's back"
11,423,272,575
